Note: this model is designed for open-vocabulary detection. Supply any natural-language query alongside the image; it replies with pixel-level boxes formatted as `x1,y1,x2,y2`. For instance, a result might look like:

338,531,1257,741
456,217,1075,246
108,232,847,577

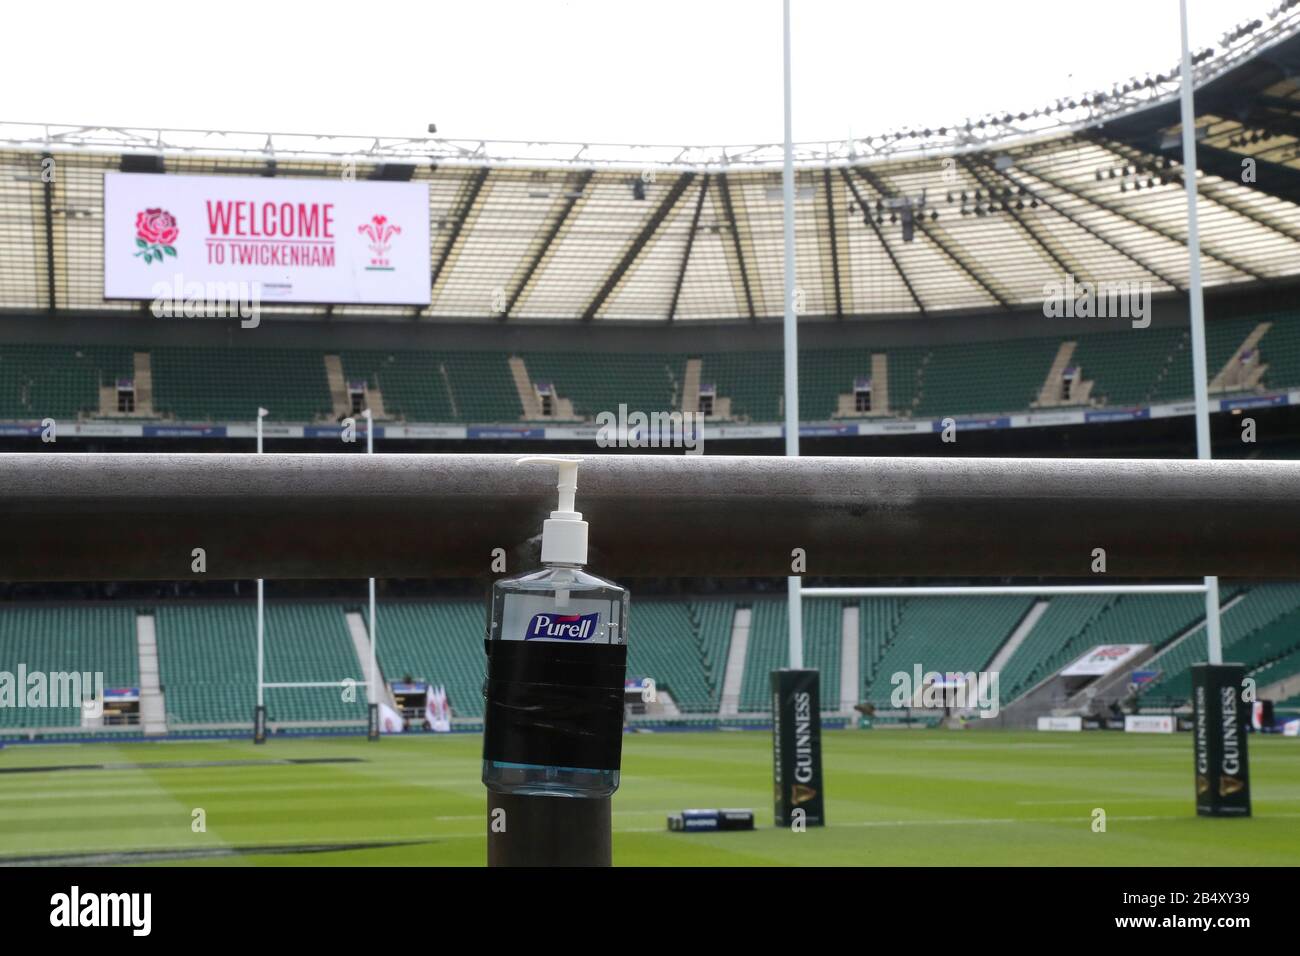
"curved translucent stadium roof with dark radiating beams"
0,6,1300,321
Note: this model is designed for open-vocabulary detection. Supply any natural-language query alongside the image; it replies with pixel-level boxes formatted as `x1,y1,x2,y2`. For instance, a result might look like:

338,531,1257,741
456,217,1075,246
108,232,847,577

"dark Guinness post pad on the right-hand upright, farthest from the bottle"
1192,663,1251,817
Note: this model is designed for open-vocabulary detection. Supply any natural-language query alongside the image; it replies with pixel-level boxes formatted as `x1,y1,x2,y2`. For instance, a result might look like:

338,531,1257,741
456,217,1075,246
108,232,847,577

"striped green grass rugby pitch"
0,731,1300,866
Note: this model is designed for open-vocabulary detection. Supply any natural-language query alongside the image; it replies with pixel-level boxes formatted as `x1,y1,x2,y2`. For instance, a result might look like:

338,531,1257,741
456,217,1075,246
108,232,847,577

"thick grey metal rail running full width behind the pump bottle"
0,453,1300,581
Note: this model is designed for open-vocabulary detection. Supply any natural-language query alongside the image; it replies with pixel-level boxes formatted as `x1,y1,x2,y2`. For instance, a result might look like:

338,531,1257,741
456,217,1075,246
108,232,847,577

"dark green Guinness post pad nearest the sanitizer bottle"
772,669,826,826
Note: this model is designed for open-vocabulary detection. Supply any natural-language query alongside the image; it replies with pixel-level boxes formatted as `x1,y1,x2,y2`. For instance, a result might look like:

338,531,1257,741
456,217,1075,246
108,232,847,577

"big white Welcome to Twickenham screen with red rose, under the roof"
104,173,430,306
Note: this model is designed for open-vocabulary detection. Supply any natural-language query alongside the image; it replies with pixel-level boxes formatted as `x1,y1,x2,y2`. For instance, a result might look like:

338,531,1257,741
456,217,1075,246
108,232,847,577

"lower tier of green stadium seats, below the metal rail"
0,583,1300,730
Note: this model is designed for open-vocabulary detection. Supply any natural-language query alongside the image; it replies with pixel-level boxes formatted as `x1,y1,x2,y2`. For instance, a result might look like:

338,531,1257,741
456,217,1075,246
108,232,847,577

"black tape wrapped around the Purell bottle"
484,641,628,770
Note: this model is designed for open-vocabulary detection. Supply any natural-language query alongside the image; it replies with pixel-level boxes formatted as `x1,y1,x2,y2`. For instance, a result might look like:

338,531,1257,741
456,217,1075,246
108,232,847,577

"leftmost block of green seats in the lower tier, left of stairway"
0,605,139,727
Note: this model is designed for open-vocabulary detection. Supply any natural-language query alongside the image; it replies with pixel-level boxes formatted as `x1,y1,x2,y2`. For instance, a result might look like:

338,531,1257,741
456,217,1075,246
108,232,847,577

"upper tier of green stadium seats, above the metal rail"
0,312,1300,424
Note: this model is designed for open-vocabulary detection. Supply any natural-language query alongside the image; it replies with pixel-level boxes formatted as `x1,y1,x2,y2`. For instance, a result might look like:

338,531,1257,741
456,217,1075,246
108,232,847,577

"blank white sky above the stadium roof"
0,0,1273,144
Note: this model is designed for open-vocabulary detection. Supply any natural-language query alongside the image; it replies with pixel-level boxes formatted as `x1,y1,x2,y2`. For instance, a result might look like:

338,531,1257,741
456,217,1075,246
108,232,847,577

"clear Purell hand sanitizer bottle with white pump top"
482,458,628,797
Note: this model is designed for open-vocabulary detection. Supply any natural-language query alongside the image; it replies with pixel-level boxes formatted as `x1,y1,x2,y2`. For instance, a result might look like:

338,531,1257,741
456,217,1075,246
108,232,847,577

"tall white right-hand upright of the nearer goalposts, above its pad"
1178,0,1223,663
